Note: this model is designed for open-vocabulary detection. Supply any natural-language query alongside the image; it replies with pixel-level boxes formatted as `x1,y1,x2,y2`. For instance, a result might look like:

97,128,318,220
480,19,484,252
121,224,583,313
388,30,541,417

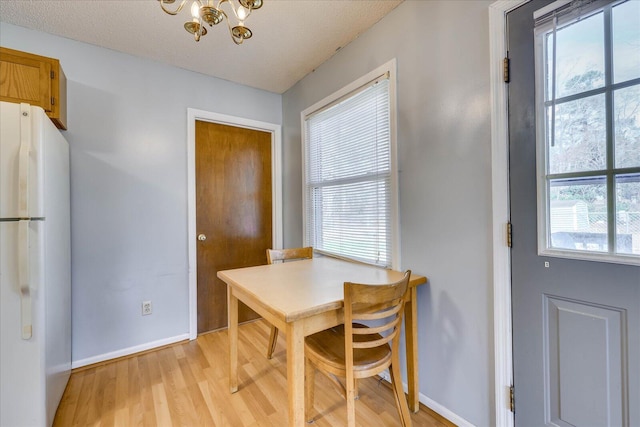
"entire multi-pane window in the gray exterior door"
536,0,640,264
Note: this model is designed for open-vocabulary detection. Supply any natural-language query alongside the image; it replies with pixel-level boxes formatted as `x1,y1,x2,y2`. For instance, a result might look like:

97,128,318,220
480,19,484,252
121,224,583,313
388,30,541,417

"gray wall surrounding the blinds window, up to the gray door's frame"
282,0,494,426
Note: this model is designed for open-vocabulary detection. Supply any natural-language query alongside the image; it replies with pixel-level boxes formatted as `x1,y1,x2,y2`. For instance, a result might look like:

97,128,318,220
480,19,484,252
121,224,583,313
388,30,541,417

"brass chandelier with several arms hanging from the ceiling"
158,0,262,44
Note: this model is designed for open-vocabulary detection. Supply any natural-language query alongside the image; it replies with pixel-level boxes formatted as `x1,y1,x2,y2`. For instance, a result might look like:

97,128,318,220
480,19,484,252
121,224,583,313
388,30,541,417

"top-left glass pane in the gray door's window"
547,12,605,98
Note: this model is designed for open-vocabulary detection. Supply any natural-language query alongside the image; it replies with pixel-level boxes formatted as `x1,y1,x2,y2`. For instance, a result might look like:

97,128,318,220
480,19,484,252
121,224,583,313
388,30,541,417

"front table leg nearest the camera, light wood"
286,322,306,427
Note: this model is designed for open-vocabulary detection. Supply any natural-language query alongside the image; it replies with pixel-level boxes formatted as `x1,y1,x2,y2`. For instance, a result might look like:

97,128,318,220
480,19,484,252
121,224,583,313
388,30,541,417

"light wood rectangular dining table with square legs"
218,257,427,427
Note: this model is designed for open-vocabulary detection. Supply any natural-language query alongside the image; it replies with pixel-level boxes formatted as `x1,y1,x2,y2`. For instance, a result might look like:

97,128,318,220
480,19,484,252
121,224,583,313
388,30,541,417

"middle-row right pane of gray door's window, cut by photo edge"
613,86,640,168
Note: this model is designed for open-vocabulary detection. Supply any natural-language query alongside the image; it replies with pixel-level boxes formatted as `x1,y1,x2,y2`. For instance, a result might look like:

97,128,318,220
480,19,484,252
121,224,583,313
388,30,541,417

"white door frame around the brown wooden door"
187,108,283,340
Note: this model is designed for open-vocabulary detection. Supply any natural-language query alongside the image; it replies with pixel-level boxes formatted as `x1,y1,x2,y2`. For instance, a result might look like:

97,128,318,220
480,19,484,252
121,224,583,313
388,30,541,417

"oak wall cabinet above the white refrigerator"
0,47,67,130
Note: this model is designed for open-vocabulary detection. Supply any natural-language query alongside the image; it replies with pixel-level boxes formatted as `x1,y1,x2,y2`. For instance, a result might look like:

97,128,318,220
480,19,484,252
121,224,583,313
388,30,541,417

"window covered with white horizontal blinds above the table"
303,62,397,267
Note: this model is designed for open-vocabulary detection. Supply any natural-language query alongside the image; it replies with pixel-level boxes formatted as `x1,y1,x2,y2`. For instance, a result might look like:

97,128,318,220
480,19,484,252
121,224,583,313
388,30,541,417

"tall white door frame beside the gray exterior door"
489,0,529,427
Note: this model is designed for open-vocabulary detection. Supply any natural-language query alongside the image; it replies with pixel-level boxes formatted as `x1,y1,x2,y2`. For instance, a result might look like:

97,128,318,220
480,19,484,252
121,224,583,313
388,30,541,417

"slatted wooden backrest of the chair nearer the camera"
344,270,411,360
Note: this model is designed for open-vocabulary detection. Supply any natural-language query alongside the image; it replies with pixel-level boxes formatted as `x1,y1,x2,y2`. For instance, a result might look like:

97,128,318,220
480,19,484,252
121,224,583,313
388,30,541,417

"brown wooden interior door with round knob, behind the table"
196,121,273,333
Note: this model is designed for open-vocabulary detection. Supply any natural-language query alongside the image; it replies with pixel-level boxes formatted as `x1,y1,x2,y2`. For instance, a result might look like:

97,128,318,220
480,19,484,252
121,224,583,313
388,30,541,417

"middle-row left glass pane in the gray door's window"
547,94,607,174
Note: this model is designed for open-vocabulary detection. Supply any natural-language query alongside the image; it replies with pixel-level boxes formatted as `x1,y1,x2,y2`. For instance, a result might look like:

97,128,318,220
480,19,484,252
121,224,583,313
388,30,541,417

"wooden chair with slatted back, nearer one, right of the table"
305,271,411,427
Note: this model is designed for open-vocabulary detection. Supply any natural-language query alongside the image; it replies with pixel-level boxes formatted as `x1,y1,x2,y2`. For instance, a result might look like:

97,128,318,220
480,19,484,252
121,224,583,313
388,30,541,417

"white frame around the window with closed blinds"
300,58,401,270
